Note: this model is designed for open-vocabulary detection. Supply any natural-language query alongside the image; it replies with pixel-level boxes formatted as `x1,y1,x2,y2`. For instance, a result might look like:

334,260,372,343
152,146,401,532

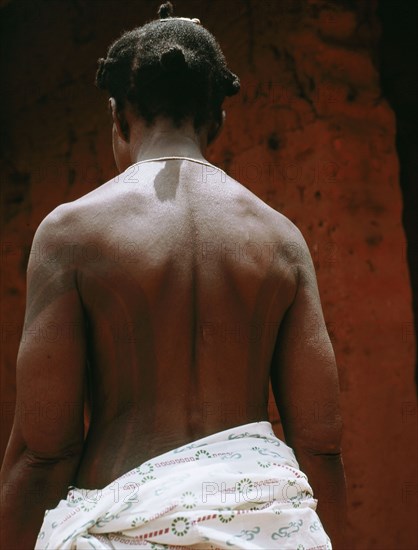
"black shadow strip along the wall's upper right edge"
377,0,418,385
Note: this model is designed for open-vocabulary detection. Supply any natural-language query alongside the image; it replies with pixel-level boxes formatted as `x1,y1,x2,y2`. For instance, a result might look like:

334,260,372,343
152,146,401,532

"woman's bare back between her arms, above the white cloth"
58,160,296,487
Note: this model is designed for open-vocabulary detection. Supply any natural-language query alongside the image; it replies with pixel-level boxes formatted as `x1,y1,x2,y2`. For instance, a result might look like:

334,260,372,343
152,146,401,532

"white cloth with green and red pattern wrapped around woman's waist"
35,421,332,550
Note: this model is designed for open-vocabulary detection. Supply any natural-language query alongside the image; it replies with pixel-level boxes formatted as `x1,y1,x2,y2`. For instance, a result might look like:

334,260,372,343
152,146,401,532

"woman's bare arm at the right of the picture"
271,229,346,548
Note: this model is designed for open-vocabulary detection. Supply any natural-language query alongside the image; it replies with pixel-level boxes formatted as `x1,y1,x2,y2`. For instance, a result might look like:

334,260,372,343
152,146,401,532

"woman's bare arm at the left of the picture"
1,211,86,550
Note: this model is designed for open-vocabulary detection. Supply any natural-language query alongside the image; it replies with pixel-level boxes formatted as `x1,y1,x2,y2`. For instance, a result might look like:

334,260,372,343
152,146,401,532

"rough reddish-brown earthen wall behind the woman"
1,0,418,550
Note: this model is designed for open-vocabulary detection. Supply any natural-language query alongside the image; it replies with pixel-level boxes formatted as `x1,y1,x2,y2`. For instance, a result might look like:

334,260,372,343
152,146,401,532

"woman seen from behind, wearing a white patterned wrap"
2,3,344,550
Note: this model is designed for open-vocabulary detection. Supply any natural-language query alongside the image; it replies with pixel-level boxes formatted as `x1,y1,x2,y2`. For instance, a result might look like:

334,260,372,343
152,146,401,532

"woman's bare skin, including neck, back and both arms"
1,99,345,549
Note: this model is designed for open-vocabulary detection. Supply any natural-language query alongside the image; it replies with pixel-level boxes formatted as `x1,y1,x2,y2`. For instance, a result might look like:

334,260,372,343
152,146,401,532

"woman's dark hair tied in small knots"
95,2,240,134
